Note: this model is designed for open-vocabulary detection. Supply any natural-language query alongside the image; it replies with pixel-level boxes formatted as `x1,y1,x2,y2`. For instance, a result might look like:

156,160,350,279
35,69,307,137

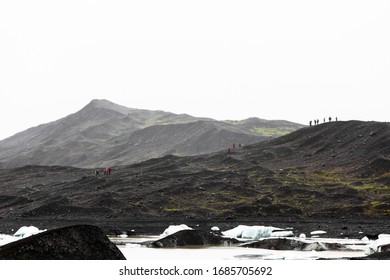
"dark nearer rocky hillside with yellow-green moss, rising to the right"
0,121,390,238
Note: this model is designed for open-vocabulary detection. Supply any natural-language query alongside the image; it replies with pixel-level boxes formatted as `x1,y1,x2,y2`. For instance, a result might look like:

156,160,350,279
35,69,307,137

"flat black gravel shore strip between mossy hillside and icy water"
0,217,390,239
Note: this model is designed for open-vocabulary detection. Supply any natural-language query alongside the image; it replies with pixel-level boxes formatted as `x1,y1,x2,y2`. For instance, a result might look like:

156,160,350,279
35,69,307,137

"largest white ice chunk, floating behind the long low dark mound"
222,225,293,240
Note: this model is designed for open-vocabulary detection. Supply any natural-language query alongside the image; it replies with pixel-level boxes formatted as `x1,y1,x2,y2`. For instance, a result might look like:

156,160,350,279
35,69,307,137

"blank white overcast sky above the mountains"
0,0,390,139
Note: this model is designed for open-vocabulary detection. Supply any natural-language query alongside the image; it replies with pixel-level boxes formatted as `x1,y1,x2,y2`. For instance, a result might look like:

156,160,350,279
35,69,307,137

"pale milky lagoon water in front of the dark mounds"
110,236,370,261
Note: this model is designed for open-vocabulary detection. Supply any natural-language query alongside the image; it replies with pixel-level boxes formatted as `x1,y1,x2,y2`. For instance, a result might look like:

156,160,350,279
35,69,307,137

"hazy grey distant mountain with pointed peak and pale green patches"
0,100,303,168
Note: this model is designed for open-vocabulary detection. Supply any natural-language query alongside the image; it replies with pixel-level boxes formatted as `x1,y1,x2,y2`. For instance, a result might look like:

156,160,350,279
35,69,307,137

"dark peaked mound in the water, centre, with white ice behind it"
145,229,238,248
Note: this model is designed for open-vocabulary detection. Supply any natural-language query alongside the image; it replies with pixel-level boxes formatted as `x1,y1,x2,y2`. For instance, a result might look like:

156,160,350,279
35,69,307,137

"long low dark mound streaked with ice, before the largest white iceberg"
241,238,345,251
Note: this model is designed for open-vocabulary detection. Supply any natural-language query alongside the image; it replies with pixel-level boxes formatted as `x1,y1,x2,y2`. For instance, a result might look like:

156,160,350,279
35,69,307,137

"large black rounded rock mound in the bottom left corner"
0,225,125,260
